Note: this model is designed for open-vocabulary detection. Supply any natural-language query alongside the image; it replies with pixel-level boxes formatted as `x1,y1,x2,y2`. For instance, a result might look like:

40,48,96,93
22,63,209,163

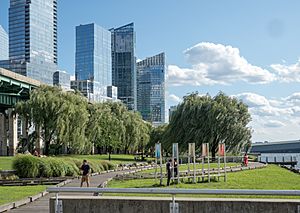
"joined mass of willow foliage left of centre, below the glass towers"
16,86,151,155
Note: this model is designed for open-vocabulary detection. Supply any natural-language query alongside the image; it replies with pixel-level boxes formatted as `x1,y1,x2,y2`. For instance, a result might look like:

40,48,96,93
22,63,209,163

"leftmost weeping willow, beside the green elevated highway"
16,86,91,155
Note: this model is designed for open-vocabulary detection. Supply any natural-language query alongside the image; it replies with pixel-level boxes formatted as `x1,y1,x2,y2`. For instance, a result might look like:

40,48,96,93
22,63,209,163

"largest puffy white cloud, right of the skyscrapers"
168,42,276,86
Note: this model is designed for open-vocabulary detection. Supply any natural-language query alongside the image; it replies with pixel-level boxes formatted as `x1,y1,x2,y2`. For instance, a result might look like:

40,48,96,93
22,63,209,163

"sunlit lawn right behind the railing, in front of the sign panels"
108,165,300,199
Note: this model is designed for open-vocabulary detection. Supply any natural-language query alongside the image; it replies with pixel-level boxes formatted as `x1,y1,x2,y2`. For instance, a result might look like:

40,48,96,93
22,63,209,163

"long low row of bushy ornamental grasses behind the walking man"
13,155,115,178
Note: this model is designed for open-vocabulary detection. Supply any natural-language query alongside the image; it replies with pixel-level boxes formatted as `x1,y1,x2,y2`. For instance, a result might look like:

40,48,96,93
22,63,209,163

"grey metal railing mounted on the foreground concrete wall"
47,187,300,212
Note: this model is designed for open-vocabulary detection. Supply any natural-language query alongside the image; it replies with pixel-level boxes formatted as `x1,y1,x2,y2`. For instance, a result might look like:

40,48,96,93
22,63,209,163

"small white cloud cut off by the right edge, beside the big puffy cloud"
271,59,300,82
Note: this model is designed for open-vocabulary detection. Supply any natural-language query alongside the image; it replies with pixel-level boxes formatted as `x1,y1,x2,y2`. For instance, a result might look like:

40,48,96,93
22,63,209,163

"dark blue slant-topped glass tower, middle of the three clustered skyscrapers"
110,23,137,110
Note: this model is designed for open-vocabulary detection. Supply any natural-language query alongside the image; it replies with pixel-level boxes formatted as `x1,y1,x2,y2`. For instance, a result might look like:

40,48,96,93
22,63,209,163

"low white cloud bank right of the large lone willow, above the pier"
235,93,300,141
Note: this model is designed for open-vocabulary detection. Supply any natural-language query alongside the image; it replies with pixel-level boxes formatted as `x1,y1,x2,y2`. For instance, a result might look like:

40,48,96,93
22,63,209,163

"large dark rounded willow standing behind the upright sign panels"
163,92,251,158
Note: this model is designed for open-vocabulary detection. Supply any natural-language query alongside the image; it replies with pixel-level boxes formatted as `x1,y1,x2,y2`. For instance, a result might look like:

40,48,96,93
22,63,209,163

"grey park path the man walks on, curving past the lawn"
9,162,262,213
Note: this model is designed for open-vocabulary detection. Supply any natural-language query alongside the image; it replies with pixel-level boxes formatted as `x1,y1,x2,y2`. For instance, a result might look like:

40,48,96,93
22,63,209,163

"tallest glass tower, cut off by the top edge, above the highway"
3,0,57,85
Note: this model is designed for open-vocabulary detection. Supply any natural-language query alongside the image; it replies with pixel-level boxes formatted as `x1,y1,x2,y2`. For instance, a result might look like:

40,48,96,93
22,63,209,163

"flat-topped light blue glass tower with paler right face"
75,23,112,101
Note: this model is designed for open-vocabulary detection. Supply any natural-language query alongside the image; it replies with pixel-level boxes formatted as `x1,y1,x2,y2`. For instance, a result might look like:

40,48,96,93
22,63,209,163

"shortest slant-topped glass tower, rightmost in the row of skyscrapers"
137,53,166,125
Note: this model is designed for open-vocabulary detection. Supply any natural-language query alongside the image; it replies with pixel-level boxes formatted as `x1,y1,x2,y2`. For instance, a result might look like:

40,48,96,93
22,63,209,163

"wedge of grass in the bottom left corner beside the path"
0,185,49,205
